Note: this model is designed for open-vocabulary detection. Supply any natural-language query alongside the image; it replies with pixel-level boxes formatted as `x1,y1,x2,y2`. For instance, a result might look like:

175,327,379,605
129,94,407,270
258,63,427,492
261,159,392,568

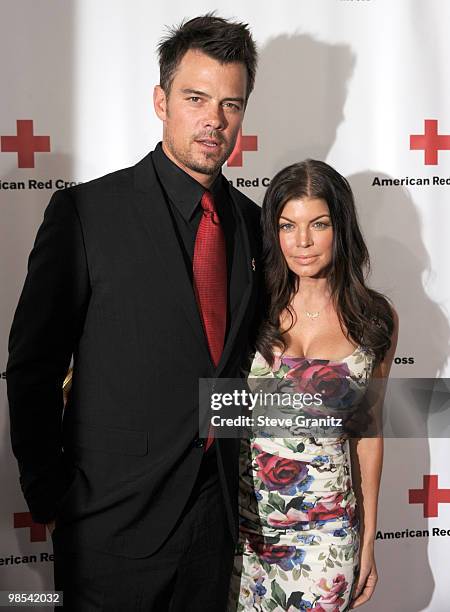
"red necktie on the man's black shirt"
192,191,227,451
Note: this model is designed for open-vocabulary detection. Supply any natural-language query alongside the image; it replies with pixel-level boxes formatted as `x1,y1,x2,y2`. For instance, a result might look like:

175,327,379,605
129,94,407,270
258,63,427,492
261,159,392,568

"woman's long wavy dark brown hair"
257,159,394,366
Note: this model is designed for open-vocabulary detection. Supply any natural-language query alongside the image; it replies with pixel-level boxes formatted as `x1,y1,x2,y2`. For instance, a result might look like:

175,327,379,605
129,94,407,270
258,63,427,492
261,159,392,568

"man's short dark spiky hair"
158,13,258,100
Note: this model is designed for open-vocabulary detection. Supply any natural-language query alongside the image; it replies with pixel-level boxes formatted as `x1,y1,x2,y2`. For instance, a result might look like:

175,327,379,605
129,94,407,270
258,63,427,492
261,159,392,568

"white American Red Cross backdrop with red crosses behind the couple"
0,0,450,612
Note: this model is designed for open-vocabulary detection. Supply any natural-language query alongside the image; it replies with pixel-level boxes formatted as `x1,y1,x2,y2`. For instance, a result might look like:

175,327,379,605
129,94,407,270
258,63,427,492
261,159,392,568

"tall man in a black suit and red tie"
7,14,260,612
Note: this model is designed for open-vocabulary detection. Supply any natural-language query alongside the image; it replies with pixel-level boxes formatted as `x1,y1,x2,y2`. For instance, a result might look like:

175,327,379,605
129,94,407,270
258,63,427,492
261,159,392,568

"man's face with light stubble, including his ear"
154,49,247,186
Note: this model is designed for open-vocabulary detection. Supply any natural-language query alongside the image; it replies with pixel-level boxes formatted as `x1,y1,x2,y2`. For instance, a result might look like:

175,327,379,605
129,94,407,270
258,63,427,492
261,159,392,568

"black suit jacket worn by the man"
7,153,260,557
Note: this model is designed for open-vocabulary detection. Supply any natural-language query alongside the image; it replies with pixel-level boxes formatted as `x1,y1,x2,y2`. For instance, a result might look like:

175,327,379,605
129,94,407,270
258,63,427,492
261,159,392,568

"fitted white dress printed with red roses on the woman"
228,346,374,612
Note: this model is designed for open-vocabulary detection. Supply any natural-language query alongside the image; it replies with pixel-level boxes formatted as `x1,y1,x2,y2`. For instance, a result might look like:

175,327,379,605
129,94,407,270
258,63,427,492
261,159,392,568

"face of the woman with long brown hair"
278,197,333,278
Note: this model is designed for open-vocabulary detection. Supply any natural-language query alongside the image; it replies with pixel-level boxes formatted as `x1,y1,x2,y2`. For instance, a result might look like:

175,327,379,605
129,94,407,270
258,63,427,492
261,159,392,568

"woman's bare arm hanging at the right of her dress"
350,310,398,609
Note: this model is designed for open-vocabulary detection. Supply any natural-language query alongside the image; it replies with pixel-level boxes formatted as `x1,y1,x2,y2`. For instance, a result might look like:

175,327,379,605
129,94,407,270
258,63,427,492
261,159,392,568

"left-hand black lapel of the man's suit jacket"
135,153,213,369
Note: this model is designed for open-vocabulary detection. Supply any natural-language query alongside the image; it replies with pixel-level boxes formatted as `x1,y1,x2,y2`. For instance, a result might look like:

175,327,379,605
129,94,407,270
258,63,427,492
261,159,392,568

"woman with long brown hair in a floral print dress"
229,160,398,612
